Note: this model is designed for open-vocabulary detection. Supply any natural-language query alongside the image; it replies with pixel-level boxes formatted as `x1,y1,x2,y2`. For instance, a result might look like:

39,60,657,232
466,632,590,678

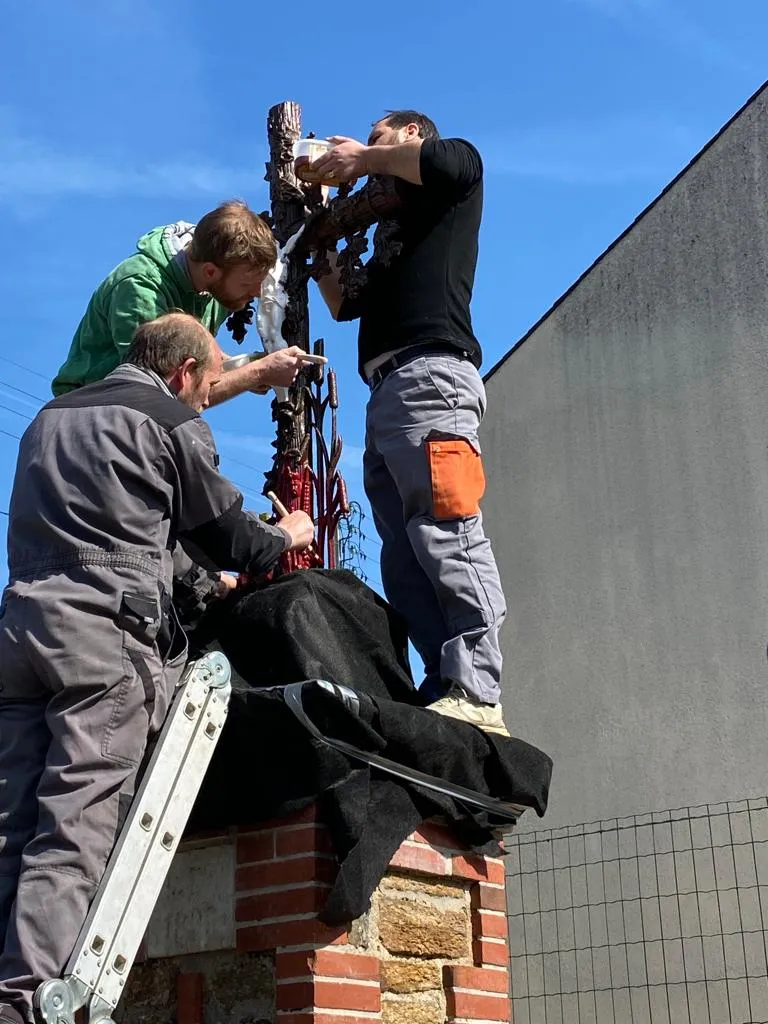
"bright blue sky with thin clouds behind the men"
0,0,768,584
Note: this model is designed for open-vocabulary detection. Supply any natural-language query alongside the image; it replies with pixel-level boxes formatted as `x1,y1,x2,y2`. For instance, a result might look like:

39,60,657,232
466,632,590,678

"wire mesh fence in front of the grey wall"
508,798,768,1024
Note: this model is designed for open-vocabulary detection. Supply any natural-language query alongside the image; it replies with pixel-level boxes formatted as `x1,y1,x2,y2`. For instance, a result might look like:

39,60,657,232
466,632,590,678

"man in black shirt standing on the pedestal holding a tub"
312,111,509,735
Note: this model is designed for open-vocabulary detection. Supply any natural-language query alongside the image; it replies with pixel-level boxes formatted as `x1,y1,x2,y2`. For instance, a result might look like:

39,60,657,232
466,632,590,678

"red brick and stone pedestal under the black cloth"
119,809,511,1024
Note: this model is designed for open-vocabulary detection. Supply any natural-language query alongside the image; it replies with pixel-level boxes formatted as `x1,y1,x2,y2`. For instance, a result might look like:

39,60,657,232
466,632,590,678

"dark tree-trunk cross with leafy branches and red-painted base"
226,101,399,572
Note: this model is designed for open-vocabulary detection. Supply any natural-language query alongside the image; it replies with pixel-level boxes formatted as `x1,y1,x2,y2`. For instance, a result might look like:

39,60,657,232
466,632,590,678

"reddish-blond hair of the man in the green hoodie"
186,200,278,270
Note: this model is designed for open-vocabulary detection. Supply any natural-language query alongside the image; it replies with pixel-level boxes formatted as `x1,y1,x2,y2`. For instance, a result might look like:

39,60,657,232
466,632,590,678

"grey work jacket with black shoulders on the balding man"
8,365,288,638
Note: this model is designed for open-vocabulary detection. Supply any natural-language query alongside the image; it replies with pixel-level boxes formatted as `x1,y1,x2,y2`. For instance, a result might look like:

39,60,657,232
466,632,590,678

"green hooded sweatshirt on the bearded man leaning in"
51,220,229,396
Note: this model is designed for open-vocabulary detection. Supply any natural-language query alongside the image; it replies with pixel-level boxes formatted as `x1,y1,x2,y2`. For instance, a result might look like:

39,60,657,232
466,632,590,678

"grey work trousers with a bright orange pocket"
364,353,506,703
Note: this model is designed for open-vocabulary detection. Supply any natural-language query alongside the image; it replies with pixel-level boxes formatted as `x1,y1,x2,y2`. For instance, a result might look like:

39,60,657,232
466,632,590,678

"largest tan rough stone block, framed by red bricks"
379,894,470,959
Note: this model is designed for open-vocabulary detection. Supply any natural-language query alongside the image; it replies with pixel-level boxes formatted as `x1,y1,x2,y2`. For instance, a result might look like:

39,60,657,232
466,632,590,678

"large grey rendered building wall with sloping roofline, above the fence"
482,81,768,827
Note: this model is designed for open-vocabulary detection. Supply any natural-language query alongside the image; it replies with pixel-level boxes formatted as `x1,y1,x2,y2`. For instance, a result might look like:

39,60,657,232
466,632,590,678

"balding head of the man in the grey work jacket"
125,313,222,411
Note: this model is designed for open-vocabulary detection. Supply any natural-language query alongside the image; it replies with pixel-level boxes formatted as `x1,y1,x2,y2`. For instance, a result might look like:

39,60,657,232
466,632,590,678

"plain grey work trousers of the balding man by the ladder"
0,567,186,1021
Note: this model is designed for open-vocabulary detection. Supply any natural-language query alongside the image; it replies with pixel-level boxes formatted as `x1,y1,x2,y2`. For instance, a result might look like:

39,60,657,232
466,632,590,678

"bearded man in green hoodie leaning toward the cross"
51,201,303,406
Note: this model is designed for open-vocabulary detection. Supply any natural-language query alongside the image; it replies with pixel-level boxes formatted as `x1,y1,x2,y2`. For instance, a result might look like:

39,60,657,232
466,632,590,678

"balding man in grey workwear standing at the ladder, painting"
0,313,314,1024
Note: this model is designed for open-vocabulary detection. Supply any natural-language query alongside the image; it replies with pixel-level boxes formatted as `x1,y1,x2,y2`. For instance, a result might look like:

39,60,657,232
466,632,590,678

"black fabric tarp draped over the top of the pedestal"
187,569,552,924
